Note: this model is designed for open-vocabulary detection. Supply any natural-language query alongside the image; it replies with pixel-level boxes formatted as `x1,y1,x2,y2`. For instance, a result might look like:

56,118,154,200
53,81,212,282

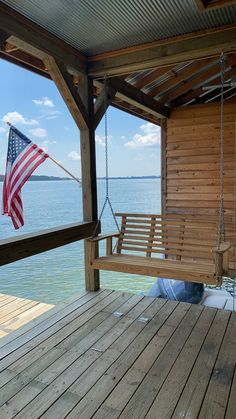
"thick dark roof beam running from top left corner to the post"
0,2,86,73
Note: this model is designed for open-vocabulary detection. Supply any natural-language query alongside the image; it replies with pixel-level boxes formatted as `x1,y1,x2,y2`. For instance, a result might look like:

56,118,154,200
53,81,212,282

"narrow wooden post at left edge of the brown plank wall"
161,119,167,214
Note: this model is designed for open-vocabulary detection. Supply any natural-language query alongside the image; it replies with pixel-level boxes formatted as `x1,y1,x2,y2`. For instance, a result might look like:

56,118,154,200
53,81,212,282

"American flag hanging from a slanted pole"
2,126,48,229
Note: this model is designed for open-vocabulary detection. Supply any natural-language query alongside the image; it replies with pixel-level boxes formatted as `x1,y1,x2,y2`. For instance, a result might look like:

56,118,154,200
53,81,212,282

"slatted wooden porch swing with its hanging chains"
89,54,231,285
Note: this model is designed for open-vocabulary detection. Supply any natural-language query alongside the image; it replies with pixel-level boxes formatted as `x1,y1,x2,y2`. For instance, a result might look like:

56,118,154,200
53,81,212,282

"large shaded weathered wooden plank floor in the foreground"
0,290,236,419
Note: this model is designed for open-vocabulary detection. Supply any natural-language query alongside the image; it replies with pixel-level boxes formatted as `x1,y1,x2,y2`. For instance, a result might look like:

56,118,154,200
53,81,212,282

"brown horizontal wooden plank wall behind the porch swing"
164,100,236,216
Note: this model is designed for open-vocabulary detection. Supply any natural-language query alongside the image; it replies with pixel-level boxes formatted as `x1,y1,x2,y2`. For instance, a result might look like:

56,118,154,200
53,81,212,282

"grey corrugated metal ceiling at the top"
2,0,236,55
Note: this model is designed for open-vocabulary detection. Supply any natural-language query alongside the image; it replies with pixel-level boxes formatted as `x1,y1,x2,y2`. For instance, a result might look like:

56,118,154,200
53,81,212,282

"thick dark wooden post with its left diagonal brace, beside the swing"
44,56,100,291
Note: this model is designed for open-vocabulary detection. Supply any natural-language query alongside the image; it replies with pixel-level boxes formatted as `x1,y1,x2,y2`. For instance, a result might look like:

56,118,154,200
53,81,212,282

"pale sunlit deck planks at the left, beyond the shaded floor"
0,294,54,338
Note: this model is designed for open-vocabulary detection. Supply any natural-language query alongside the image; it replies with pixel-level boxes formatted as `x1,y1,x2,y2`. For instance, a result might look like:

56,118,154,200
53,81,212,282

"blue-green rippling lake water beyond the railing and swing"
0,179,161,303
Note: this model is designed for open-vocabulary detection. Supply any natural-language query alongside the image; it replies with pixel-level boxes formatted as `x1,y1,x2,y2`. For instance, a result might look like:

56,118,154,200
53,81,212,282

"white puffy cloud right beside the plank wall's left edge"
125,122,160,149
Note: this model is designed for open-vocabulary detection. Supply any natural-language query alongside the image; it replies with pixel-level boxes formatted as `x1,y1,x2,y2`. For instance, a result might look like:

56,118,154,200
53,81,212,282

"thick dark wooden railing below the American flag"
0,221,99,266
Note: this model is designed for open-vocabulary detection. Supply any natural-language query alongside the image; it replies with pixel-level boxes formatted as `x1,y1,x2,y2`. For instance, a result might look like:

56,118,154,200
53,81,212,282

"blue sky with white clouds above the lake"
0,59,160,177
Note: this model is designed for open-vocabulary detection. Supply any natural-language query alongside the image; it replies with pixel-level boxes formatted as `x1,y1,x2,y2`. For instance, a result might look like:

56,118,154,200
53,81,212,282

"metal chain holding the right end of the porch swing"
216,52,225,280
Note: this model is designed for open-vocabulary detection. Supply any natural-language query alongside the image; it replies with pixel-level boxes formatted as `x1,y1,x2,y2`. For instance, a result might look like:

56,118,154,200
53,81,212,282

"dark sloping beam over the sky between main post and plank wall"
110,77,169,118
